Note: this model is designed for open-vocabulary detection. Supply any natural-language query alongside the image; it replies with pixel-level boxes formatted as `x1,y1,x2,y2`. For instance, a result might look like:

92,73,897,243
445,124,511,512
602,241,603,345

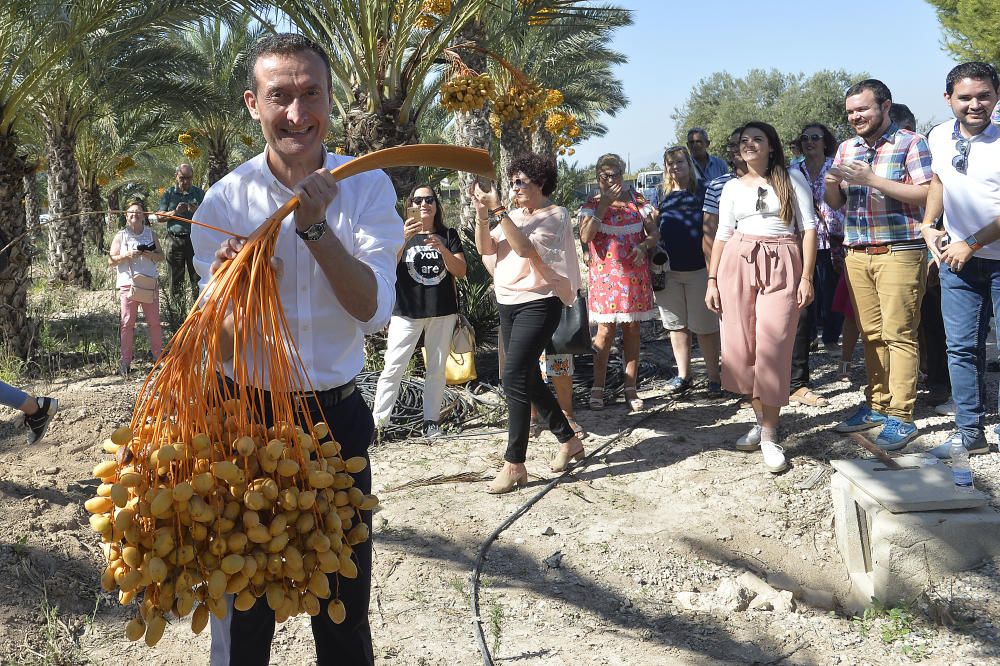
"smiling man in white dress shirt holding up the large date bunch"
192,34,403,666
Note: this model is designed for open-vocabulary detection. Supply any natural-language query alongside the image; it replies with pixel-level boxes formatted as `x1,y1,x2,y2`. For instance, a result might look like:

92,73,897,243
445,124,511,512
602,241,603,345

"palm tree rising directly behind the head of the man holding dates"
277,0,493,196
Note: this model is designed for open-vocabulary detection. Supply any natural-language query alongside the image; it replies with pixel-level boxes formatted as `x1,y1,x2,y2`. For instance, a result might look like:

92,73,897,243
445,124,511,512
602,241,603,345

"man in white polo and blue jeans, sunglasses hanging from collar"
921,62,1000,458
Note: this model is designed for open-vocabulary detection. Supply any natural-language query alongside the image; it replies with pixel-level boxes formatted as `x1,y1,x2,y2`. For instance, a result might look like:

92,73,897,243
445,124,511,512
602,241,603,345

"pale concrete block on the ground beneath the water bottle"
830,456,1000,612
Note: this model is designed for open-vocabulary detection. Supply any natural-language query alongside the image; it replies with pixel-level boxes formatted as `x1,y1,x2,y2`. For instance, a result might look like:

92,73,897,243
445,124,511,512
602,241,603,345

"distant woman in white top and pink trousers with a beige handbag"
108,198,163,377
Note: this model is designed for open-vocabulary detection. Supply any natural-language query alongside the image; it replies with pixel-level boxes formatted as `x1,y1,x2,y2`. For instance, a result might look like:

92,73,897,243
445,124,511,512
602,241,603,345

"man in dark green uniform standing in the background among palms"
156,164,205,303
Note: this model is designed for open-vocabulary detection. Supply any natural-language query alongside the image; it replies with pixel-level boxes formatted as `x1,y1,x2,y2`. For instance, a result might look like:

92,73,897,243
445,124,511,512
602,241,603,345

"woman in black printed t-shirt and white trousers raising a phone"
373,185,466,437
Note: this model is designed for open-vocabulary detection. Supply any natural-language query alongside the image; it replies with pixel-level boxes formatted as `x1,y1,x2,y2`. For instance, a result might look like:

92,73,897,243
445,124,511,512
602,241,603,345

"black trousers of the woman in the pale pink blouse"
498,296,574,463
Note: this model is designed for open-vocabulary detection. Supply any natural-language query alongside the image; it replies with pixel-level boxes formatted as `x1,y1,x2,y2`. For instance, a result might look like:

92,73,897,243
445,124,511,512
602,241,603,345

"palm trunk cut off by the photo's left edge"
0,132,35,359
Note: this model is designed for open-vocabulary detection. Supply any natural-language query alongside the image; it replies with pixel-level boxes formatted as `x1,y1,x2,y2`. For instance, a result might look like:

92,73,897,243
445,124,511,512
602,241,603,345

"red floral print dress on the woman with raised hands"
580,195,659,323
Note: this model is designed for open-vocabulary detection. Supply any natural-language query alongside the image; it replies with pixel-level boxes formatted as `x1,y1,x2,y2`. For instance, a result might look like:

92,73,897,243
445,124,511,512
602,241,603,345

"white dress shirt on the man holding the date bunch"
191,152,403,390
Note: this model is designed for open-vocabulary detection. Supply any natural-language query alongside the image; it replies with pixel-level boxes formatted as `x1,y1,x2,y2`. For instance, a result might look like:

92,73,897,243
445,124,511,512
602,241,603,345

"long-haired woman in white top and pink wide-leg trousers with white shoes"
705,121,816,473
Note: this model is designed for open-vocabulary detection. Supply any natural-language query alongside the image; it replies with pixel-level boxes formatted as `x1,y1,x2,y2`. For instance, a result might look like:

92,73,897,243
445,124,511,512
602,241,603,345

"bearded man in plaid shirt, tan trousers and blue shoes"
824,79,933,451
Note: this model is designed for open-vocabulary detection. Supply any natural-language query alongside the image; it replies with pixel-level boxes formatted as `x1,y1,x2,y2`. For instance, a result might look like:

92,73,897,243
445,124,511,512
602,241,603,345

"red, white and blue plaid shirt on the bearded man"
833,123,933,246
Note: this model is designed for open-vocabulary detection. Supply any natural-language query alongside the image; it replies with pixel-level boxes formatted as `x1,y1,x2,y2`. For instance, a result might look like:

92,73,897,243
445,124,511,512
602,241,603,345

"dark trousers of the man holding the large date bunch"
212,384,375,666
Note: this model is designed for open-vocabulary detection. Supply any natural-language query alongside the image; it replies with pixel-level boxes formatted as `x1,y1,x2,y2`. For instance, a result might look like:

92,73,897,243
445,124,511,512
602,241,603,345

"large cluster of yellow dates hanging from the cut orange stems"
85,410,378,646
